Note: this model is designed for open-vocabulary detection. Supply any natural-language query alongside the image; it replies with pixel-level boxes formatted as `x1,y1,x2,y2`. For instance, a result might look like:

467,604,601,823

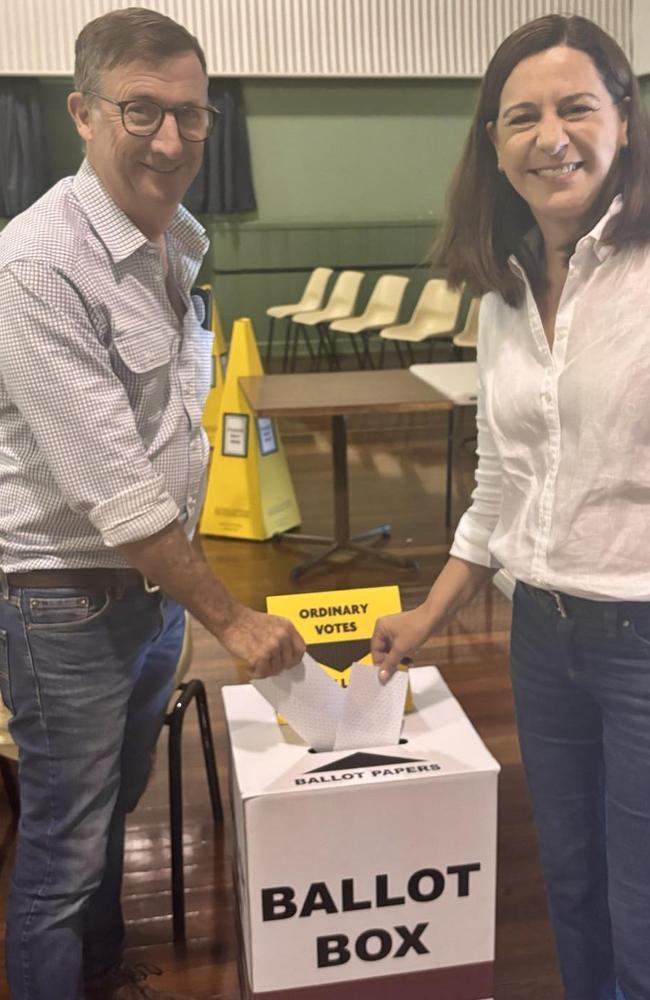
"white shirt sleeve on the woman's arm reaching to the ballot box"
450,303,502,569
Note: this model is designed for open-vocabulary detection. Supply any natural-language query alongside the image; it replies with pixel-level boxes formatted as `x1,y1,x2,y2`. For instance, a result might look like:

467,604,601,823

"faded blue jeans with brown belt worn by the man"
0,588,184,1000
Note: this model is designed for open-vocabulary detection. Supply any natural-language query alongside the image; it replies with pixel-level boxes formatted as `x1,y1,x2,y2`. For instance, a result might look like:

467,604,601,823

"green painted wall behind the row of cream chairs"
10,77,650,352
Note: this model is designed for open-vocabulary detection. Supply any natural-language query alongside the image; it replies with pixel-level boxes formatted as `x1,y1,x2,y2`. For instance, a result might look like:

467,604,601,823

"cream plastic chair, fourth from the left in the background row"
379,278,463,367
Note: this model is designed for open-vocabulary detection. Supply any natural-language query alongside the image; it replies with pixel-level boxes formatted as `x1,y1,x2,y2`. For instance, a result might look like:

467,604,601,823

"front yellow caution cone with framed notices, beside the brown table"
200,319,300,540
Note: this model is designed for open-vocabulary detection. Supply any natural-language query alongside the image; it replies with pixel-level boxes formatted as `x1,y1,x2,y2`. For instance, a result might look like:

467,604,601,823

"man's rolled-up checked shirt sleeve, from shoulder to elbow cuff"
0,261,179,547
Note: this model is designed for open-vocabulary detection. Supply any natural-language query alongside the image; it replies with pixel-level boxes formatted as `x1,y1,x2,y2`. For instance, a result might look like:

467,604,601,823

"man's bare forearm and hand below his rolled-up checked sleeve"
117,521,305,677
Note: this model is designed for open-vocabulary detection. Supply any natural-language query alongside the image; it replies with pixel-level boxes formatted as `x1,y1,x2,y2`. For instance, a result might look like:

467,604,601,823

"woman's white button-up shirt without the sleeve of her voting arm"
451,198,650,601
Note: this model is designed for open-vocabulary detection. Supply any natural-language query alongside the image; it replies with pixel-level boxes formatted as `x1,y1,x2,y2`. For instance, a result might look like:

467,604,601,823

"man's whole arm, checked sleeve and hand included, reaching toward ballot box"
0,262,304,676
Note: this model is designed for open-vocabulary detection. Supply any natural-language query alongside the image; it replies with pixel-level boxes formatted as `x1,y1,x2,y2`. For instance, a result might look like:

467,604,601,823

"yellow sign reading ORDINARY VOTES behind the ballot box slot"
266,586,413,711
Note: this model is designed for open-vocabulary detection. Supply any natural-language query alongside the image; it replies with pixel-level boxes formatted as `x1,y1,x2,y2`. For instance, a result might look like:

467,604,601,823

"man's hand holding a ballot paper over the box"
218,604,305,678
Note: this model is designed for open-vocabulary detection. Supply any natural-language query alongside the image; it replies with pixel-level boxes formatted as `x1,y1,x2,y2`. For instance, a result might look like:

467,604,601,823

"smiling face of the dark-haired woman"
488,45,627,239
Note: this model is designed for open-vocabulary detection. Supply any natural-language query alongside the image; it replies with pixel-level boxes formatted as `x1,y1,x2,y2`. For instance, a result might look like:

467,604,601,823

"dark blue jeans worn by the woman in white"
511,584,650,1000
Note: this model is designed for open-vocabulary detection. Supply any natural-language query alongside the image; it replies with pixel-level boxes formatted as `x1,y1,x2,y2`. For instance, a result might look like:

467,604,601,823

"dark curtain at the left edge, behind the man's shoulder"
0,77,46,218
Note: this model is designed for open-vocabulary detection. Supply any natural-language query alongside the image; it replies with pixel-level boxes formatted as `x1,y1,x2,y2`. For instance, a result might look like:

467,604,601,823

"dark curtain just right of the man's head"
185,79,257,215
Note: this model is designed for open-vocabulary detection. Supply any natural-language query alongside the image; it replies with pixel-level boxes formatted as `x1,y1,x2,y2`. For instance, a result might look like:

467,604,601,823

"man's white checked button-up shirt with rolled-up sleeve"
0,162,212,571
